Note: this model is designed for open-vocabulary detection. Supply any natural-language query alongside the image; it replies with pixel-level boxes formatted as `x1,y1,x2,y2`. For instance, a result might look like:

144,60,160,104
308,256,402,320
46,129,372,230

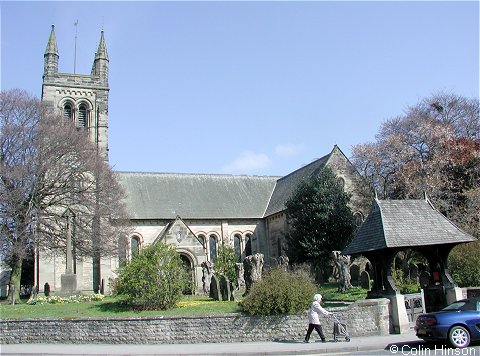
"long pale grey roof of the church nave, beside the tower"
117,172,279,219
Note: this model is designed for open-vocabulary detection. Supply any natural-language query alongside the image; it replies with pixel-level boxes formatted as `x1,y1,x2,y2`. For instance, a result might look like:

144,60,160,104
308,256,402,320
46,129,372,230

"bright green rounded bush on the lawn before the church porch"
114,243,190,310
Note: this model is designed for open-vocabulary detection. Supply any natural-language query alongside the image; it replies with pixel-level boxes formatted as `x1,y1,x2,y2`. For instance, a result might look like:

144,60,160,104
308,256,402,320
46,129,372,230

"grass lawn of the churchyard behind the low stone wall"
0,283,367,319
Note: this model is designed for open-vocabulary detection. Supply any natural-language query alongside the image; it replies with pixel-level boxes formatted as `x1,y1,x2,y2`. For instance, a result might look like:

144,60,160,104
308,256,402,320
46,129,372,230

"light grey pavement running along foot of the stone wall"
0,329,423,356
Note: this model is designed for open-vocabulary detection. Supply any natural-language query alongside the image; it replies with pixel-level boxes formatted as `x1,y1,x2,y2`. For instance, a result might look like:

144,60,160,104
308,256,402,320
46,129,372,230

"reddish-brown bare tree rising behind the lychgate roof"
352,93,480,236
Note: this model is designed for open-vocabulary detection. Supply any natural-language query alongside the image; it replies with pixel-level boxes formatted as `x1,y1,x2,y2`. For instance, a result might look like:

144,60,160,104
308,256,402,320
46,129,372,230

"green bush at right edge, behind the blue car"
448,241,480,287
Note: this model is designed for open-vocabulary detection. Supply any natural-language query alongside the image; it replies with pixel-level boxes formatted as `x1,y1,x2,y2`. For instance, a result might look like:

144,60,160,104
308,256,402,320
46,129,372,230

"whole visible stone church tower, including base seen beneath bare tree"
37,25,112,292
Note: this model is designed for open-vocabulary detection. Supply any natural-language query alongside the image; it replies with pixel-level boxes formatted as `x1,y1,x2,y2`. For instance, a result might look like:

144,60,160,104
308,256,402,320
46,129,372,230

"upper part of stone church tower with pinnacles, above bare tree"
42,25,109,161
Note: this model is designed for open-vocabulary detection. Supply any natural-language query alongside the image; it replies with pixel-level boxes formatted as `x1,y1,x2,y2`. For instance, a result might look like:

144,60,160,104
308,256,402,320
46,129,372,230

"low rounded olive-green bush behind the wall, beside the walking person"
241,267,317,315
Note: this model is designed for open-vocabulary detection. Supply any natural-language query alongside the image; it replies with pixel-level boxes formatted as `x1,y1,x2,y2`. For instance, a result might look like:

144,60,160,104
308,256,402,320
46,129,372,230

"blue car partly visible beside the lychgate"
415,298,480,348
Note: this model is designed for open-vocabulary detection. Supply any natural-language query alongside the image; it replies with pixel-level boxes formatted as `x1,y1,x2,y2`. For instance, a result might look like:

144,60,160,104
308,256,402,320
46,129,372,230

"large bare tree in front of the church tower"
0,90,128,299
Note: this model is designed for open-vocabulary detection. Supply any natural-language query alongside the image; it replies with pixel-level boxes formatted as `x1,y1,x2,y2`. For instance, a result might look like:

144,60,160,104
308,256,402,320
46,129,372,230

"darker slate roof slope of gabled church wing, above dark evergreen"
265,151,336,216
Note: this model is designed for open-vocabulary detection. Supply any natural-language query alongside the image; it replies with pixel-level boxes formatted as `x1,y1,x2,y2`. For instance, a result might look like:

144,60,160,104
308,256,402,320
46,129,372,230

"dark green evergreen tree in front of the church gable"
286,167,355,278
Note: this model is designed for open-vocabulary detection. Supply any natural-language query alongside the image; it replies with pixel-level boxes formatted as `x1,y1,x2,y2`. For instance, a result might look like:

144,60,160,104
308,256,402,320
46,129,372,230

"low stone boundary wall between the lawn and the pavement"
0,299,389,344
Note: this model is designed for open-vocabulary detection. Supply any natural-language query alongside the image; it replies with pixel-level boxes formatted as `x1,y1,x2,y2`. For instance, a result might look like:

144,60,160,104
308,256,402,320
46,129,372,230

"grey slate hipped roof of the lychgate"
342,199,476,255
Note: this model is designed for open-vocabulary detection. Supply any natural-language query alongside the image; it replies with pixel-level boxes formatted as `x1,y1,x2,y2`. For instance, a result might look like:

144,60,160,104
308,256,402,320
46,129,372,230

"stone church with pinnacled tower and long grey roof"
34,26,364,293
